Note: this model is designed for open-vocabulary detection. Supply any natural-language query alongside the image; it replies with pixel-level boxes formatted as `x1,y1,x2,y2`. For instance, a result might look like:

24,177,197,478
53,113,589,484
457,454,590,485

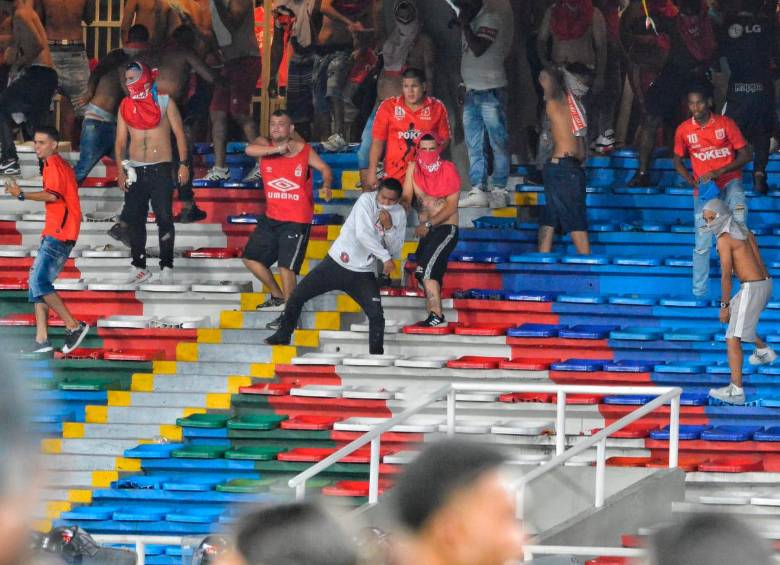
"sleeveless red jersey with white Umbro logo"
260,144,314,224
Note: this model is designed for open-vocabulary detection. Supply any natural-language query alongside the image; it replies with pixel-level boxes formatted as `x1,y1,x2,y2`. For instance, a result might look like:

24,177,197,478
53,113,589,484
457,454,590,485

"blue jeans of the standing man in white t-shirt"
463,88,509,191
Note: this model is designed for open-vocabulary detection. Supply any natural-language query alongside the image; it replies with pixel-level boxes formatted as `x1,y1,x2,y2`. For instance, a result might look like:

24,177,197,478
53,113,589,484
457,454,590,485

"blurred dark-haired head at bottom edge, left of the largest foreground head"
218,503,358,565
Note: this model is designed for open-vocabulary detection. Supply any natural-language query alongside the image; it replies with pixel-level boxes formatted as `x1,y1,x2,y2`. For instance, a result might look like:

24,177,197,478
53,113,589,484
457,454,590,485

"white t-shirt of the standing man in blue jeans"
460,0,515,90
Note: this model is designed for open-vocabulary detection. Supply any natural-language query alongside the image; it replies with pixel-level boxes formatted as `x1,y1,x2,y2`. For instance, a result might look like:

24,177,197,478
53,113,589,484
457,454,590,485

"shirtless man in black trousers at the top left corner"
0,0,57,175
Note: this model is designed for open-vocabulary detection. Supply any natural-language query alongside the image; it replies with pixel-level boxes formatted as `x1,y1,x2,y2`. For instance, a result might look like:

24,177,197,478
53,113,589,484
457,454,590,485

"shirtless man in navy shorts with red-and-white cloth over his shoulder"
539,66,590,255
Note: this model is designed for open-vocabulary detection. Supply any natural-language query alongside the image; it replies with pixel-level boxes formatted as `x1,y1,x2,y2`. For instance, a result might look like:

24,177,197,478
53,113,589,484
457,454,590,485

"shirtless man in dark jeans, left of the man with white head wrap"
313,0,382,144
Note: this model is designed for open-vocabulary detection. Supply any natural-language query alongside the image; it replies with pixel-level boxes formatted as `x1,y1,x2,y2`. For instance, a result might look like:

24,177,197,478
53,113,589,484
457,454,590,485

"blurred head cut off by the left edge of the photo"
0,353,40,565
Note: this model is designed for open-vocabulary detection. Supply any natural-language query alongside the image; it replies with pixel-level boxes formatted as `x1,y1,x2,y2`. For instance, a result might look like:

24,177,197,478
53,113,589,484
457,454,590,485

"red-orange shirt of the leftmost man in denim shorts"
41,153,81,241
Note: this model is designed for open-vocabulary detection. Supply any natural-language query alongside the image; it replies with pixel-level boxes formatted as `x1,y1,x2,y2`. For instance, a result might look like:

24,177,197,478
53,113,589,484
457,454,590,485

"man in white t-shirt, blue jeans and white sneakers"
453,0,514,208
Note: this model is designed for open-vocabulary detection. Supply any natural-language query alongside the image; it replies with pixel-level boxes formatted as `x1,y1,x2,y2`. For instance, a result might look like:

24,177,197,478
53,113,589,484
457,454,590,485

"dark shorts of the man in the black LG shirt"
723,82,777,138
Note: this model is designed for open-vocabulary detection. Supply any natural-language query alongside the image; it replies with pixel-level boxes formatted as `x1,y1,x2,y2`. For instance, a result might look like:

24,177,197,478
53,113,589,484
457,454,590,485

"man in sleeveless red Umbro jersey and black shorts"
244,110,333,329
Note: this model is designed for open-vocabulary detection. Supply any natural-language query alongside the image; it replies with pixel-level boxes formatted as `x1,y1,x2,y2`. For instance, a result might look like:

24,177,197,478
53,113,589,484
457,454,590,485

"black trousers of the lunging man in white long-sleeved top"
277,255,385,355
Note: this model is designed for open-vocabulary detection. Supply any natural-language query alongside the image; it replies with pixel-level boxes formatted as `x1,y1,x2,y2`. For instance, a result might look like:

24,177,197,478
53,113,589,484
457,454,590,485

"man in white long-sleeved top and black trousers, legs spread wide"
265,178,406,355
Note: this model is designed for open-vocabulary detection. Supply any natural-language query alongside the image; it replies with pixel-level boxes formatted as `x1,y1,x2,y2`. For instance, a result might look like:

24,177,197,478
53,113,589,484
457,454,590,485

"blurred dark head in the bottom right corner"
649,514,774,565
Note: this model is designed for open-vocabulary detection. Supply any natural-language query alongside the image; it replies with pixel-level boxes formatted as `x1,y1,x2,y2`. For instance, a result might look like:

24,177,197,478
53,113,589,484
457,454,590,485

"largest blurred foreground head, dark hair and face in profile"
394,440,523,565
